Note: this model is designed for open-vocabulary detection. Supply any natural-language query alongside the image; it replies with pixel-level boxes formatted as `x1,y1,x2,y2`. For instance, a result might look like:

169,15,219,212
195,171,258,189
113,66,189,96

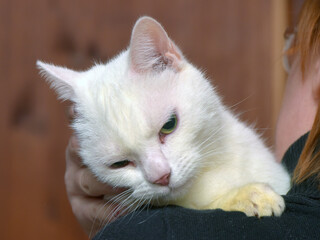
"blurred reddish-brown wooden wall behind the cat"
0,0,303,240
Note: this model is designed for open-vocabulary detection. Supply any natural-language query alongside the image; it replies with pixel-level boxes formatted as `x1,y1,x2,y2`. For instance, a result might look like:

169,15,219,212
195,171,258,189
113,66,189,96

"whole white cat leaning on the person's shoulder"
37,17,290,216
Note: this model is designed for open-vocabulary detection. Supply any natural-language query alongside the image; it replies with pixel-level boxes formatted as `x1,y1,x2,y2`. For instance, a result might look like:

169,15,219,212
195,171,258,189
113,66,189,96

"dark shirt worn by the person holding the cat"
94,135,320,240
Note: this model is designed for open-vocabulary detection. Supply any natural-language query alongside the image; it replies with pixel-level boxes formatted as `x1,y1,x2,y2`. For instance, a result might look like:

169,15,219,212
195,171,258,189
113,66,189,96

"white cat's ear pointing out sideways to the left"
37,61,80,101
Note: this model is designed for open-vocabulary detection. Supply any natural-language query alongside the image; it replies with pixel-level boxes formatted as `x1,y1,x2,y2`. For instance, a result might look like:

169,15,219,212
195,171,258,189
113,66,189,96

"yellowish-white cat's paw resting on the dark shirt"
212,183,285,217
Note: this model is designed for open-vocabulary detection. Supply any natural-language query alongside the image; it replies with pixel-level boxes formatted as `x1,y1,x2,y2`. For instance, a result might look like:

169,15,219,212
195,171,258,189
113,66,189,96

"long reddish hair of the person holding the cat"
292,0,320,187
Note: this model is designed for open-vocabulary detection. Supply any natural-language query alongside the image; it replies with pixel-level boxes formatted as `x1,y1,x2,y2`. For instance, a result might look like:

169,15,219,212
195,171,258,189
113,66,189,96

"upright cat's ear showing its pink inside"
129,17,183,73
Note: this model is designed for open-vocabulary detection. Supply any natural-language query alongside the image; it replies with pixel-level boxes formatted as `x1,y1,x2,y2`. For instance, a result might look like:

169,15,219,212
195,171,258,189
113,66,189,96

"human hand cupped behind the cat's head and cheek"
65,107,123,237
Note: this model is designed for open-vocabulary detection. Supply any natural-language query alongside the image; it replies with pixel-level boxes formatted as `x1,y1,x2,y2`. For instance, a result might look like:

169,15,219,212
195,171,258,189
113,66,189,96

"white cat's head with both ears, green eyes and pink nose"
37,17,221,204
